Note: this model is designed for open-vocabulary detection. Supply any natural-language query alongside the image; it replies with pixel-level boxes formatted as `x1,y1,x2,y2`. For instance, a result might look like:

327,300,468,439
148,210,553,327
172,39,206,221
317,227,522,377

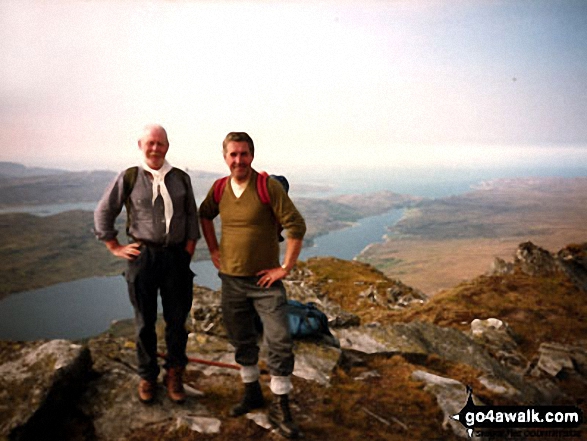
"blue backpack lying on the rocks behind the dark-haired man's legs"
286,300,333,338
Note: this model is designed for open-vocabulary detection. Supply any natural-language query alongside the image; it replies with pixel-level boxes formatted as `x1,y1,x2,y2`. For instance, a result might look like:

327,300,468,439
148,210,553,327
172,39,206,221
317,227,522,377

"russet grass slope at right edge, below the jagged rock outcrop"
387,272,587,356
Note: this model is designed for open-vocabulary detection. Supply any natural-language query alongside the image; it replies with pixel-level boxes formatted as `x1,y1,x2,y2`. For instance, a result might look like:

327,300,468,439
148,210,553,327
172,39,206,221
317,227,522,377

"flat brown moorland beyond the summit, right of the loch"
359,178,587,295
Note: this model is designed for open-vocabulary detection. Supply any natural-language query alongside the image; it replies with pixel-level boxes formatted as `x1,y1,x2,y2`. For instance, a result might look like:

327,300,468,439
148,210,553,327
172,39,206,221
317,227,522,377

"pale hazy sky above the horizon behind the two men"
0,0,587,174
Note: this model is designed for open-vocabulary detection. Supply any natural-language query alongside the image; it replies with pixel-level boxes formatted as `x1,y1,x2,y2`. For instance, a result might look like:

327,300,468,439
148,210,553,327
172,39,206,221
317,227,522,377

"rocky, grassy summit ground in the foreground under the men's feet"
0,243,587,440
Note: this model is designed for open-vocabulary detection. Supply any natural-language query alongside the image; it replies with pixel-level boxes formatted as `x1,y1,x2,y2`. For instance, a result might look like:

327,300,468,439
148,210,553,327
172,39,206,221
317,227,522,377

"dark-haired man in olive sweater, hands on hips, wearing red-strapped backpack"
200,132,306,438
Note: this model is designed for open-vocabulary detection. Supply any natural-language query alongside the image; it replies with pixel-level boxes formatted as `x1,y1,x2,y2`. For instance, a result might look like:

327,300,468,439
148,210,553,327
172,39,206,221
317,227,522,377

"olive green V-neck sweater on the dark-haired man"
199,171,306,276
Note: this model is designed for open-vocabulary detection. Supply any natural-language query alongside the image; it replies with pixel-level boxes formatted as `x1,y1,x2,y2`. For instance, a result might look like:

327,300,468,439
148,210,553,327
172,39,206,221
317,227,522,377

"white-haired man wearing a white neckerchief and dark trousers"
94,125,200,403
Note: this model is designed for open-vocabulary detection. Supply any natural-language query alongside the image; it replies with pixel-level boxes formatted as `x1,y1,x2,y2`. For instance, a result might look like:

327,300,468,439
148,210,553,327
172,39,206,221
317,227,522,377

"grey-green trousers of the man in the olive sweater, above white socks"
218,273,294,376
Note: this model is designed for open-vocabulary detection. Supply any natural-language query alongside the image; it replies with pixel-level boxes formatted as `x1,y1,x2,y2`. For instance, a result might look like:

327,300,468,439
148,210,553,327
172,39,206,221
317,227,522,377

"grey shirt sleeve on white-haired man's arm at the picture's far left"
94,172,124,241
